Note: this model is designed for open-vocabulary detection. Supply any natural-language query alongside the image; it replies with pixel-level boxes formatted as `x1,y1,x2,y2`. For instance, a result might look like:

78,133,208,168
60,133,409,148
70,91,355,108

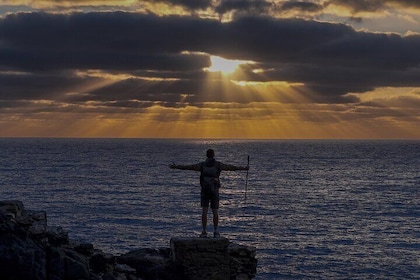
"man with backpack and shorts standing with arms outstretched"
169,149,249,237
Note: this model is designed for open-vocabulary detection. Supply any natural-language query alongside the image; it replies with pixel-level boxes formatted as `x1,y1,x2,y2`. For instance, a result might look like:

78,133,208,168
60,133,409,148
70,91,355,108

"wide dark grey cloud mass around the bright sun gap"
0,10,420,106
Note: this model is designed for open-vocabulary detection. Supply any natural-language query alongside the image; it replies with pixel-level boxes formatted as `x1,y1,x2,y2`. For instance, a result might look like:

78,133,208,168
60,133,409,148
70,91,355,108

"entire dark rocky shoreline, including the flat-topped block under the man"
0,201,257,280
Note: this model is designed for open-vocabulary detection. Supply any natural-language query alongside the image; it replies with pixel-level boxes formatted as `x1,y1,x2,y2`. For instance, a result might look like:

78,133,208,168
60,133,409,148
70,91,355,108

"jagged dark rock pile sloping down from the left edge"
0,201,120,280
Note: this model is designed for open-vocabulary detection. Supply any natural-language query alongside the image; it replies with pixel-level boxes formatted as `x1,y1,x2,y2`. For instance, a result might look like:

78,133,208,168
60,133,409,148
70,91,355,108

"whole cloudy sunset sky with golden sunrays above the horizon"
0,0,420,139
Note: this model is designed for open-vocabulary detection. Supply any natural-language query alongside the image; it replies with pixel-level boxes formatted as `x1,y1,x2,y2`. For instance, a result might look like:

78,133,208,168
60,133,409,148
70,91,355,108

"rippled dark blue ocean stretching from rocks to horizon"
0,138,420,279
